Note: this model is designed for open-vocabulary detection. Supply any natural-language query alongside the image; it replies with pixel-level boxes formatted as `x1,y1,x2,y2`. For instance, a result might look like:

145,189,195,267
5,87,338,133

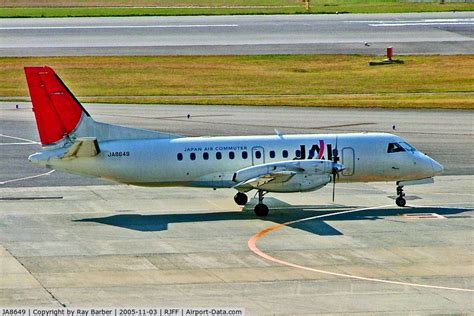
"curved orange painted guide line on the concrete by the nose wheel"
247,204,474,292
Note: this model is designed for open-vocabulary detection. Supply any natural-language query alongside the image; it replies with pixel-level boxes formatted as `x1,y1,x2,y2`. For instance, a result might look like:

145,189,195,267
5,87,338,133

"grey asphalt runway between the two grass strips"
0,12,474,56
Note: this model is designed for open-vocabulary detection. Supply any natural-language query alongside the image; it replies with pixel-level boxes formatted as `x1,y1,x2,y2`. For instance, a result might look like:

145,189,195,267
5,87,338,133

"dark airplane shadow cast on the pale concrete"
73,198,467,236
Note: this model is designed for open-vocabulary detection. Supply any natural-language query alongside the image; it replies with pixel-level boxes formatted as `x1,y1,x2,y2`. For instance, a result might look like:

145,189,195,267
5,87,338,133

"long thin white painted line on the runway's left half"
0,24,239,30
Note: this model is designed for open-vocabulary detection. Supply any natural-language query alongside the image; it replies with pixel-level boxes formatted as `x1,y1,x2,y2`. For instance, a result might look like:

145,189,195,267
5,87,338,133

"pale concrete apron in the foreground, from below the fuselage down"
0,176,474,315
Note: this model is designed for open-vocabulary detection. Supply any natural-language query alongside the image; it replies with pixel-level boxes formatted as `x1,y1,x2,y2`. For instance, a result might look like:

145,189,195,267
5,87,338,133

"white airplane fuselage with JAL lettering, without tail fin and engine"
30,133,442,188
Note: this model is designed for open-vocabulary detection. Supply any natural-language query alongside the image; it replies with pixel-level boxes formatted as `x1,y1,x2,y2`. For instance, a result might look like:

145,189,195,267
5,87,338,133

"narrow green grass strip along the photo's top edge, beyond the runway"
0,0,474,18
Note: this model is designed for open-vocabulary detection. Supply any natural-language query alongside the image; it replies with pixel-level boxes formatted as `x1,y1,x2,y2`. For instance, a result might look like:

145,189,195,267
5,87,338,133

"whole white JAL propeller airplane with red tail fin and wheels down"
25,66,443,216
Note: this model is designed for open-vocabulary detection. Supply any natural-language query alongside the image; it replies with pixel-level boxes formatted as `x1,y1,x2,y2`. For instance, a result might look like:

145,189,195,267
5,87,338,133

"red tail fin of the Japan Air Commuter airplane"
25,66,89,145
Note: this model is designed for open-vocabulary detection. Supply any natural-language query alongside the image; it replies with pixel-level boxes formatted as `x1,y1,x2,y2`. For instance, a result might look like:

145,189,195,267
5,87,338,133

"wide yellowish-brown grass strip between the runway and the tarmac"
0,55,474,109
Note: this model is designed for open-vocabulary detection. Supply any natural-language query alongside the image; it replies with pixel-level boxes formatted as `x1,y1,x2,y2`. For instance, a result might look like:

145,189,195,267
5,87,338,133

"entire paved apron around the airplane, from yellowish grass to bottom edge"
0,103,474,315
